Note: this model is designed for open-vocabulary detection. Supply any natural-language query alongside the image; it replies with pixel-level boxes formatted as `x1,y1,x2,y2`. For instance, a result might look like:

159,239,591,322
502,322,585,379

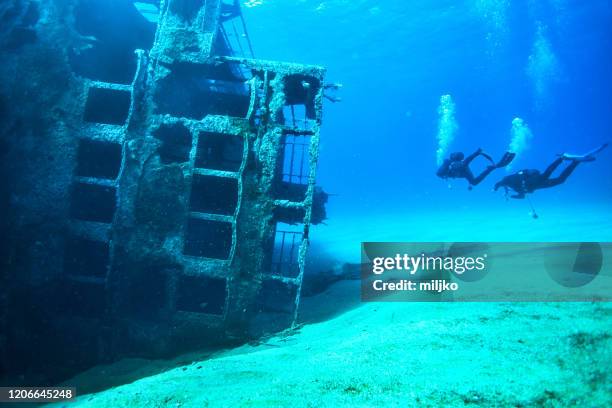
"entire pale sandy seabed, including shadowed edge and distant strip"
49,209,612,408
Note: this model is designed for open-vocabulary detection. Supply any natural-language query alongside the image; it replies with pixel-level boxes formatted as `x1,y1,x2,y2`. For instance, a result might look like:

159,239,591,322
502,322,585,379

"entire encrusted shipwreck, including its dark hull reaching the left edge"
0,0,325,382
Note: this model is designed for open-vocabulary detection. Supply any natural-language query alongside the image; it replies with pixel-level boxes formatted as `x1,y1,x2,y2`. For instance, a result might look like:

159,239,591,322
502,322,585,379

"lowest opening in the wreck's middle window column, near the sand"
176,275,227,315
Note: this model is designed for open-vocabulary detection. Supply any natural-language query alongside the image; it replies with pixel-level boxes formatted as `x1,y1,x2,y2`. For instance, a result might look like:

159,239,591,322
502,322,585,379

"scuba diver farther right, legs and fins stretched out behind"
495,143,608,199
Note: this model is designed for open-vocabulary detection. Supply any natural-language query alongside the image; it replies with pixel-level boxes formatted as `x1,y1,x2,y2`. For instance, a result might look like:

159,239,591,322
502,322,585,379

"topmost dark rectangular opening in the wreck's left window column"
83,87,132,125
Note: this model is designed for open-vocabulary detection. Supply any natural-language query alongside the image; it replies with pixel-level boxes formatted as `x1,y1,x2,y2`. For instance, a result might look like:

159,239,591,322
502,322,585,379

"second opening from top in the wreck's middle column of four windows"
189,174,238,215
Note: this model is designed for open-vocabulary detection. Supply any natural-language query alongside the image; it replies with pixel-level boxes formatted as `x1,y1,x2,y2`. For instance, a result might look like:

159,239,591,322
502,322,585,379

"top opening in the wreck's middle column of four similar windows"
195,132,244,171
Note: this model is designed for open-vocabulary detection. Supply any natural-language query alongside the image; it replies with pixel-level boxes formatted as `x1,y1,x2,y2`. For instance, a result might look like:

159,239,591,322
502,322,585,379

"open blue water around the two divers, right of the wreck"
243,0,612,230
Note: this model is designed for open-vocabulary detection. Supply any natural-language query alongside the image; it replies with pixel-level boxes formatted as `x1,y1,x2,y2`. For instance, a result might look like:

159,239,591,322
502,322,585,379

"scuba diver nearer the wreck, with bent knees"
436,149,516,190
